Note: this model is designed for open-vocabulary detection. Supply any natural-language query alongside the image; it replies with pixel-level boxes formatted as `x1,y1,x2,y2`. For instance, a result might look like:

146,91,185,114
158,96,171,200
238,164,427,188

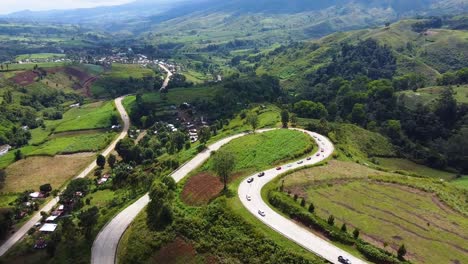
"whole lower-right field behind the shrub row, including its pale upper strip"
284,160,468,263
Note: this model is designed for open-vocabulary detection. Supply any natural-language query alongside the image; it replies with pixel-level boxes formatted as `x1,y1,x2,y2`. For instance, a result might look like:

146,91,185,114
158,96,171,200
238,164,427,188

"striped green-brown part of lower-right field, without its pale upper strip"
307,182,468,263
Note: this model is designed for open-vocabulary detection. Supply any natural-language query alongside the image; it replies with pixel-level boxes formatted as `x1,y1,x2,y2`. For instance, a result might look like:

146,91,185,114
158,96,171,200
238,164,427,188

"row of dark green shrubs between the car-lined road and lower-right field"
268,191,410,264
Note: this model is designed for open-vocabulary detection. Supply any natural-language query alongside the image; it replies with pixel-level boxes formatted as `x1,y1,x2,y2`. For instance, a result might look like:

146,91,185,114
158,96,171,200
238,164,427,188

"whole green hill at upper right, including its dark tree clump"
254,16,468,88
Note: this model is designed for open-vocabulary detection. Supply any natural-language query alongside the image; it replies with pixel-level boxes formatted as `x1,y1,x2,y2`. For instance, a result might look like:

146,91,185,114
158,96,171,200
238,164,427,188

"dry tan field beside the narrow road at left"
0,153,94,193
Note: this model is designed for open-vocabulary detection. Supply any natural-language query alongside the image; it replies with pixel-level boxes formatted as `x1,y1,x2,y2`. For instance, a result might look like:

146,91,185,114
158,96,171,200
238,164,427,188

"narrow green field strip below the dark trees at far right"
377,158,456,180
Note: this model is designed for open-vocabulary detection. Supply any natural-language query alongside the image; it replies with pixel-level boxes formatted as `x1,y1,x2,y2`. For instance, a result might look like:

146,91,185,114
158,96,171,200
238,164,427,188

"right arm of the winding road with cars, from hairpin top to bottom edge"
238,129,365,264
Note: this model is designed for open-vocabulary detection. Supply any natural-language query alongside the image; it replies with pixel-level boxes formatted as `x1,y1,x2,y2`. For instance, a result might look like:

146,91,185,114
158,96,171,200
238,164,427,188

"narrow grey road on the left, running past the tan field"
0,96,130,256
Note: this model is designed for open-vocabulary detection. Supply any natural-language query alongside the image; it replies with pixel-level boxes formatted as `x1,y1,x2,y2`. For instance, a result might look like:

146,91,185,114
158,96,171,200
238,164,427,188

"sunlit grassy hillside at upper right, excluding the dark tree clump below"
257,20,468,88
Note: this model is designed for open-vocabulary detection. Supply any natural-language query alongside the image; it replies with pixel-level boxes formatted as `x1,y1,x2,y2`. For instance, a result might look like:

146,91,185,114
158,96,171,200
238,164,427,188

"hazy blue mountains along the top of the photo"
0,0,468,36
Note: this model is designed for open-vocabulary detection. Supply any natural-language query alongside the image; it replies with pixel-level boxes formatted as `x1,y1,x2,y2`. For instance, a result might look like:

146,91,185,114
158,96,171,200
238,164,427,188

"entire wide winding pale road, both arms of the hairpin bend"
91,129,365,264
